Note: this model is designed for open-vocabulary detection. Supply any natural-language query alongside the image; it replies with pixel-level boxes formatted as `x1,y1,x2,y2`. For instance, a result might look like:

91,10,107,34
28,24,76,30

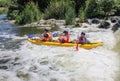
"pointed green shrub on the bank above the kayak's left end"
16,2,41,24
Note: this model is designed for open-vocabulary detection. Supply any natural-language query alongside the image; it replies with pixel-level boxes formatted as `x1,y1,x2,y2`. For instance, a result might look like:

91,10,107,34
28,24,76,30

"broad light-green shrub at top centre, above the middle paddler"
44,0,70,19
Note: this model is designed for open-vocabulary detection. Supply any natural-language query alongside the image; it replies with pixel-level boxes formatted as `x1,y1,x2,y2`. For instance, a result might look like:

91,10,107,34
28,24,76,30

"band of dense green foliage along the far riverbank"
8,0,120,24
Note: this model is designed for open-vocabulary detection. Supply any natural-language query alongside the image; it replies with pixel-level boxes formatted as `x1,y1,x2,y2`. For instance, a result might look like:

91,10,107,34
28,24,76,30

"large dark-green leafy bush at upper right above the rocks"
79,0,115,18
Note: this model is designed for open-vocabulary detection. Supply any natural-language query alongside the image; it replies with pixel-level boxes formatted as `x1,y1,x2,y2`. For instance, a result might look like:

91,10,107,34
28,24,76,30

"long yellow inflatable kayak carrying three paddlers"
28,38,103,49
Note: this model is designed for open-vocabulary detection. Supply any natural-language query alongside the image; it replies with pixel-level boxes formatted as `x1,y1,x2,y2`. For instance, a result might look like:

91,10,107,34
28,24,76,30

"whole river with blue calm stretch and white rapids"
0,15,120,81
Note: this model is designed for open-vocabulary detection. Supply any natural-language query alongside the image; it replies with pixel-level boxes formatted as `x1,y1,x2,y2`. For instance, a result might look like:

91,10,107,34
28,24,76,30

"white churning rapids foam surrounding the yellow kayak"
0,28,119,81
